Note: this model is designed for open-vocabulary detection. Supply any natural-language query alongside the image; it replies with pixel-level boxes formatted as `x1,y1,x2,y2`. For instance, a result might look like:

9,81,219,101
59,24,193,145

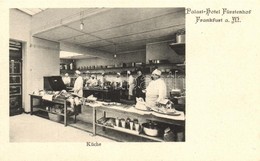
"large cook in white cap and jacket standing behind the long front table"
145,69,167,108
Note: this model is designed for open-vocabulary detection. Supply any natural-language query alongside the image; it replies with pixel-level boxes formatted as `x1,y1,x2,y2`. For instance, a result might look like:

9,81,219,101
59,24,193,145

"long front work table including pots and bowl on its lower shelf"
89,102,185,142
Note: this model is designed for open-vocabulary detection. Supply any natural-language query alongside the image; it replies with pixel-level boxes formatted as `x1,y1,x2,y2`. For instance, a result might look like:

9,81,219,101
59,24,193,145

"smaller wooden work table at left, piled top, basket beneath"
30,94,77,126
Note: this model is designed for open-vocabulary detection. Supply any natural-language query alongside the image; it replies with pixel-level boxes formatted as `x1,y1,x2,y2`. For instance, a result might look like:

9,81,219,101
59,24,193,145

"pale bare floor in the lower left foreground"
10,114,114,142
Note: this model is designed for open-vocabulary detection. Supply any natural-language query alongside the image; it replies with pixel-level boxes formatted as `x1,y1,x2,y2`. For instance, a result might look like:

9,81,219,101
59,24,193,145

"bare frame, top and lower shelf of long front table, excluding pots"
87,103,185,142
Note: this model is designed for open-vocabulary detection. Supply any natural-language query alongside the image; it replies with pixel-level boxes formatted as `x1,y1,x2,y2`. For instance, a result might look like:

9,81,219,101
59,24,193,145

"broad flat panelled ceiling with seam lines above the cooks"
33,8,185,58
